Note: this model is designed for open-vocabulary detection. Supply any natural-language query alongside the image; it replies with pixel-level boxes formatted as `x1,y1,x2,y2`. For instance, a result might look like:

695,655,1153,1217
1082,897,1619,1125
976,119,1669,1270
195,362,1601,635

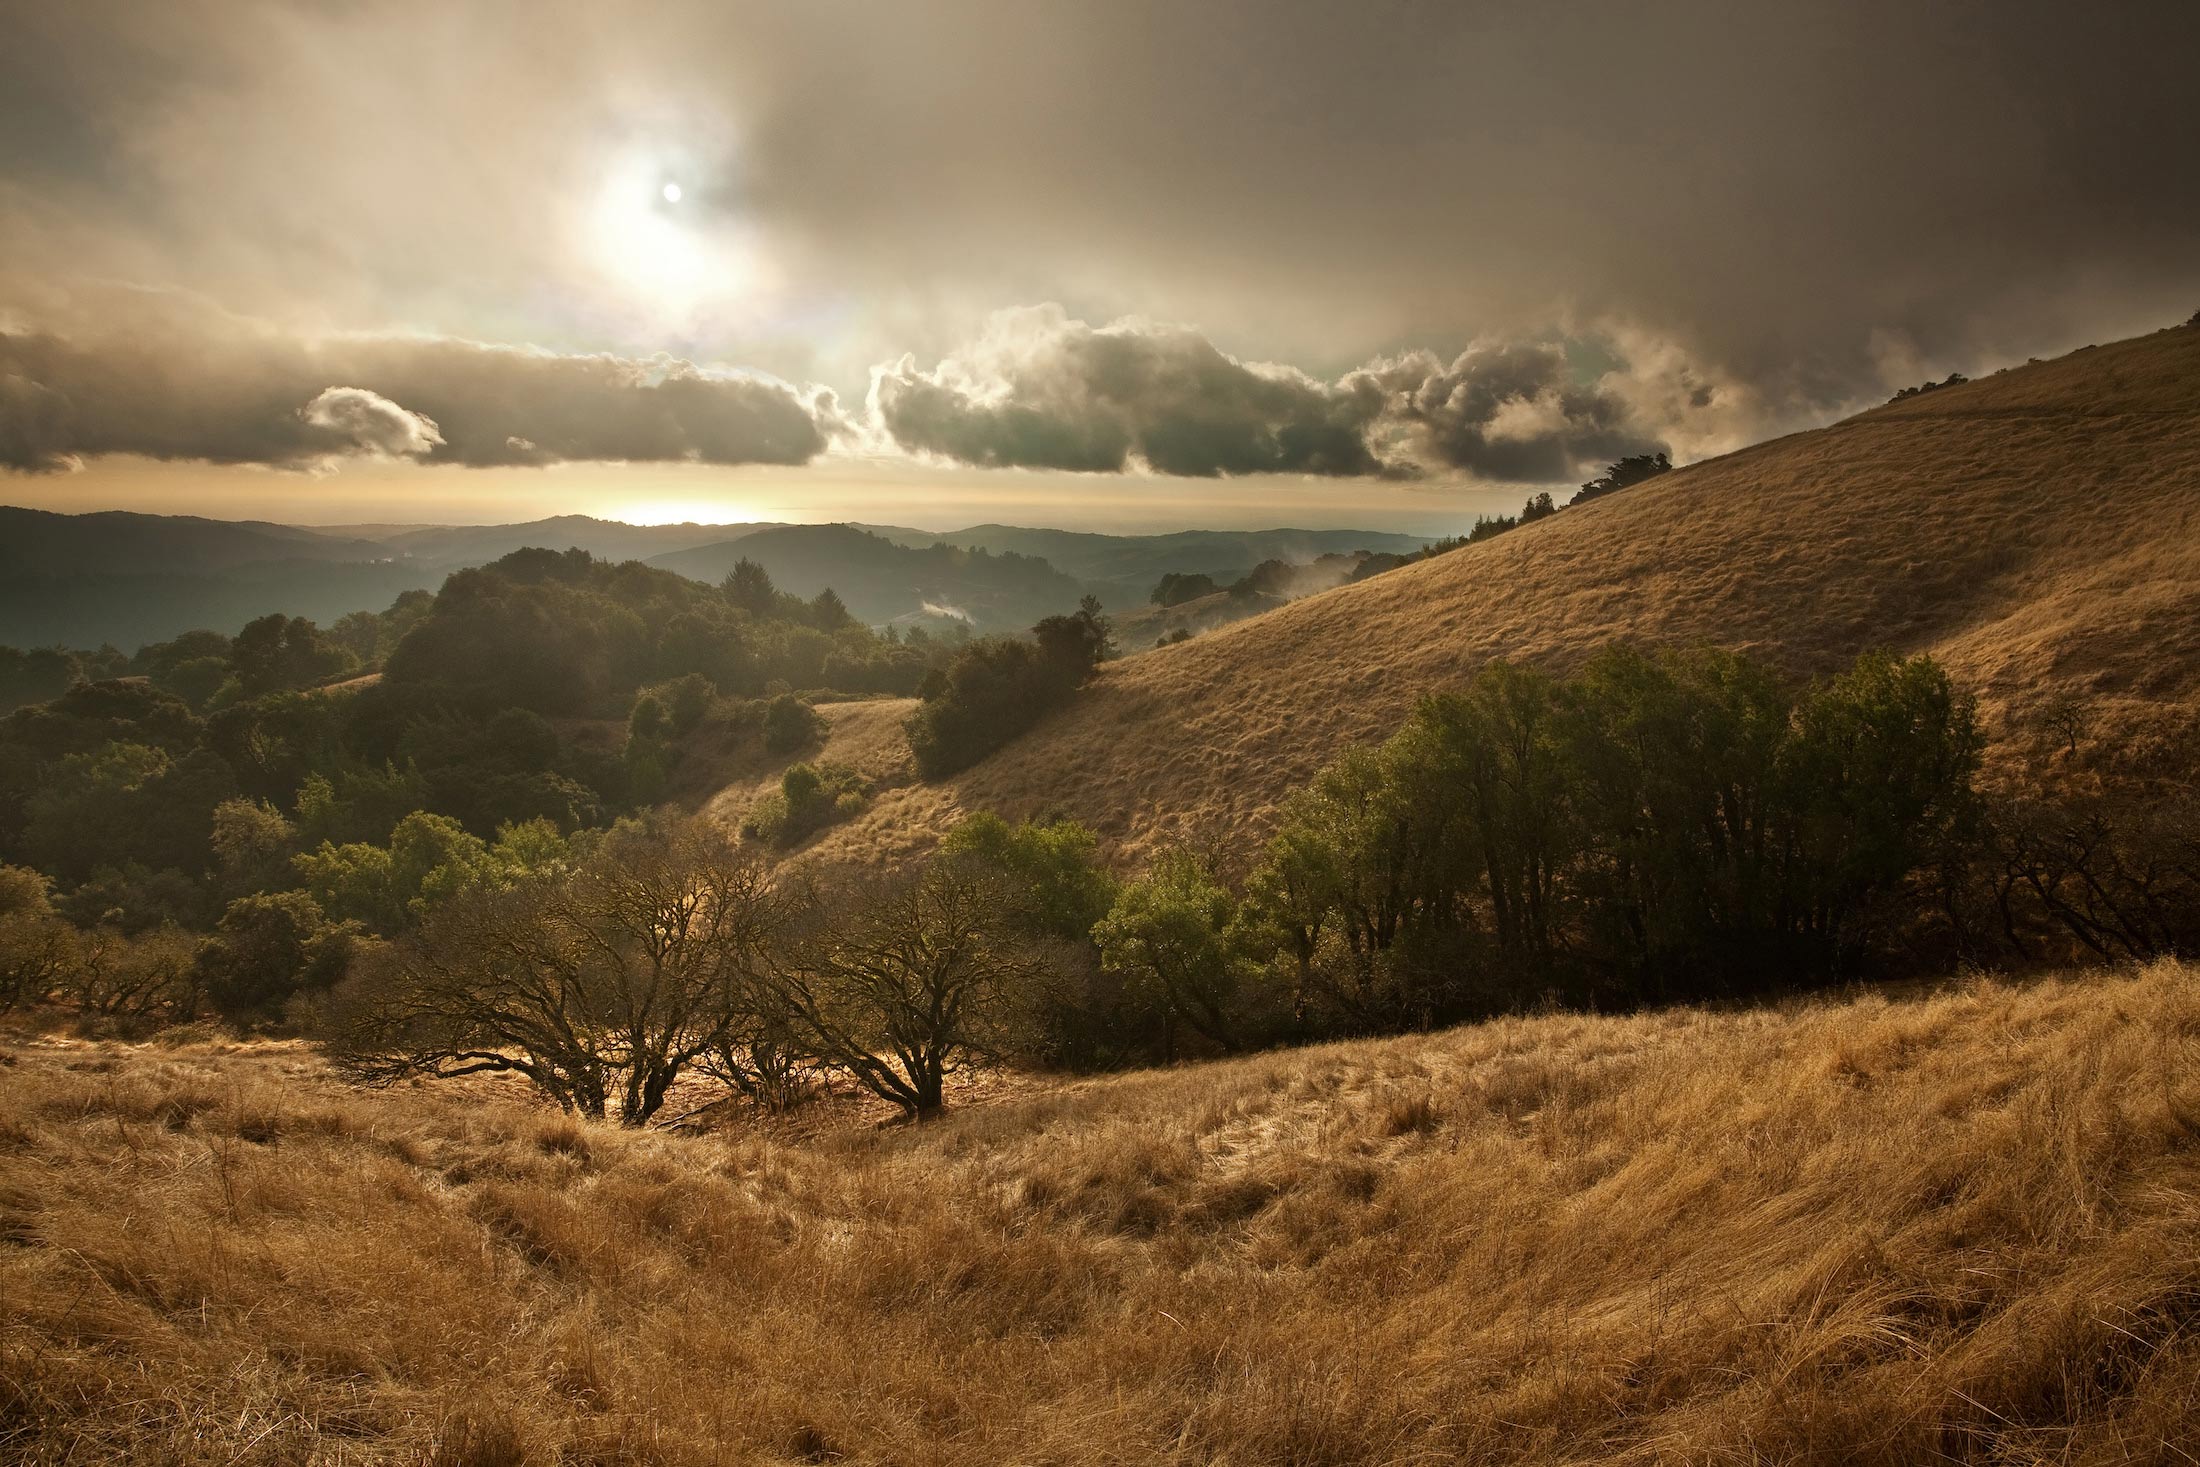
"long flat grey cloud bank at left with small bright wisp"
0,303,838,473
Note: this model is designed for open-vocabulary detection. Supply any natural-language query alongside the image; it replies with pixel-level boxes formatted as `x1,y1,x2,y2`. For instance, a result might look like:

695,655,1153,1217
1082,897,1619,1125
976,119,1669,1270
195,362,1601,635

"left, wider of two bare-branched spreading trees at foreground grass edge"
326,818,779,1126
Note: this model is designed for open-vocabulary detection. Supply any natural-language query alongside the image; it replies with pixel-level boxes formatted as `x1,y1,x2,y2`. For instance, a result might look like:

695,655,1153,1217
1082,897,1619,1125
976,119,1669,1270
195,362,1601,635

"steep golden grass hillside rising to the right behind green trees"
787,330,2200,860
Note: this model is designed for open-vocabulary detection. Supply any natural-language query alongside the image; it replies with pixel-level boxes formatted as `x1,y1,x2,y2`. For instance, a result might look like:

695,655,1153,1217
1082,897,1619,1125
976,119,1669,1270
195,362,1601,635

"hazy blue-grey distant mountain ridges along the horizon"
0,506,1419,649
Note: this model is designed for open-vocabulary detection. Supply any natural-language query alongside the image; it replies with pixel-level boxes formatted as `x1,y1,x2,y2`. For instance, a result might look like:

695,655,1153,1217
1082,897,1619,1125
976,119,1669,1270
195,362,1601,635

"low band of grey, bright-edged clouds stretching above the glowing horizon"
0,293,1764,484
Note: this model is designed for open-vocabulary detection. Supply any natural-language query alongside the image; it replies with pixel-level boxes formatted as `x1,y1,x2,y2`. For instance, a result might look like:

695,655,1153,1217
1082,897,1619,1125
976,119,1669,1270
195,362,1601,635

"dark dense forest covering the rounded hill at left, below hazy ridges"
0,550,955,945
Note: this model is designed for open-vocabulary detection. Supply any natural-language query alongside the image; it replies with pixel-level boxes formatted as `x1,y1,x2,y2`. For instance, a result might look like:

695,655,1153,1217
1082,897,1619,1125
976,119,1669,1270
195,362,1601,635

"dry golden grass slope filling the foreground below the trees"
0,966,2200,1465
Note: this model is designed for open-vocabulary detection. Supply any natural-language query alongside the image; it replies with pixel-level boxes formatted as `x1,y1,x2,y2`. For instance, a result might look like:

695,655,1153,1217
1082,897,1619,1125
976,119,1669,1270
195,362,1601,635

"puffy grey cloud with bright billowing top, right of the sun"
871,306,1672,484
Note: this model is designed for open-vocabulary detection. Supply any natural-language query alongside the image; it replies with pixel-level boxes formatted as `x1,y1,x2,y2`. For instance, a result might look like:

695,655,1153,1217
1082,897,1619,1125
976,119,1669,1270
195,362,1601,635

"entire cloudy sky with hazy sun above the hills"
0,0,2200,534
